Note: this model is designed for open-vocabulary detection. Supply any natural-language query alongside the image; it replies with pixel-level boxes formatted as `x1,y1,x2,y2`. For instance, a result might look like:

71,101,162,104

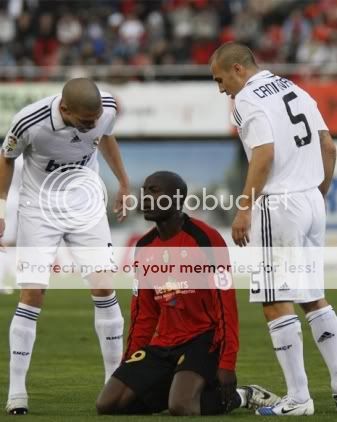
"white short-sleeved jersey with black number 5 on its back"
231,70,327,194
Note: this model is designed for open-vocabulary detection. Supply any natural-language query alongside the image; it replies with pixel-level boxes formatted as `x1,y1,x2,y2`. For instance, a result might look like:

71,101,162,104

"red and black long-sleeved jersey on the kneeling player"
125,215,239,369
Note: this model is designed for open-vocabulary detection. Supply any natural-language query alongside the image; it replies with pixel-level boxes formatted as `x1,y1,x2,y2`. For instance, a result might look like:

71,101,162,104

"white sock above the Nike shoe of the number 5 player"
268,315,310,403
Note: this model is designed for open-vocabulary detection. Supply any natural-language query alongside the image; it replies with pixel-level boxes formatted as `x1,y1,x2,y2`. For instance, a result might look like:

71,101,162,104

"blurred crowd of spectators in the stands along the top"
0,0,337,73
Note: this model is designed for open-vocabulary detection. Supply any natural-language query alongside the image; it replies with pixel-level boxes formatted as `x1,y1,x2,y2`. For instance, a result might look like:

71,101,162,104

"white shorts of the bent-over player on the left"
17,210,113,286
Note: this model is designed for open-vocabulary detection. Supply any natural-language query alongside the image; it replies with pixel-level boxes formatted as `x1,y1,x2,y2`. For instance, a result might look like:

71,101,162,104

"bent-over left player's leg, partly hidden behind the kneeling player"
88,273,124,383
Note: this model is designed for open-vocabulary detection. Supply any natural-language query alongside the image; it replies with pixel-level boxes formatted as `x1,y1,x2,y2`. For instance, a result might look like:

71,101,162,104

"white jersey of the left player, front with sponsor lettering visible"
2,92,117,208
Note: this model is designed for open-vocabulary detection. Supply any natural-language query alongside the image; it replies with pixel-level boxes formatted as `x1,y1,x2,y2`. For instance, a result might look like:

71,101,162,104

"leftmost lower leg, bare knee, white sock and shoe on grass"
6,285,45,414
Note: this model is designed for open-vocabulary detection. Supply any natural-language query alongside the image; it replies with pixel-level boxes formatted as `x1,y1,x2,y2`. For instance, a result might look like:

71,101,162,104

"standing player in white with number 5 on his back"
211,43,337,416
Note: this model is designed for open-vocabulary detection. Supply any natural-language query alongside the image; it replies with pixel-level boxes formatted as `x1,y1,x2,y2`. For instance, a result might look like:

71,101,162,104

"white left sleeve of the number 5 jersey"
233,100,274,149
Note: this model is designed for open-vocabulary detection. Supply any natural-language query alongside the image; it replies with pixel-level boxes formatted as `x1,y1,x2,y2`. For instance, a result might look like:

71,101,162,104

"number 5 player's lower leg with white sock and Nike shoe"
257,302,314,416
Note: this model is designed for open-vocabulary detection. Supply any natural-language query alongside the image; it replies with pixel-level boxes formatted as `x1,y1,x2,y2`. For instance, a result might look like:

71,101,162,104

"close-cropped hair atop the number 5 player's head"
210,42,257,69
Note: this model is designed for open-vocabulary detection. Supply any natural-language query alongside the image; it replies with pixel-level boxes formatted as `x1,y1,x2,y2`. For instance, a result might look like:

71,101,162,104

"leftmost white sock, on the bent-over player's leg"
8,303,41,398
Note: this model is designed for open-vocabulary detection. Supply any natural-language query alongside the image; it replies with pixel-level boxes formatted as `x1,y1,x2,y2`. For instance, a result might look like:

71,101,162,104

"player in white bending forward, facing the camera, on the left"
0,78,129,414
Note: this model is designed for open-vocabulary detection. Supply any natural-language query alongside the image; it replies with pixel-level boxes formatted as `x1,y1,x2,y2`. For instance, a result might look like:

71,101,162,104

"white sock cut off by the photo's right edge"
306,305,337,394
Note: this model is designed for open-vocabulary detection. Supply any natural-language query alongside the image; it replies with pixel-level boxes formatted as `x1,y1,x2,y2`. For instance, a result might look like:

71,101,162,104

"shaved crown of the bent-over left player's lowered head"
62,78,102,113
